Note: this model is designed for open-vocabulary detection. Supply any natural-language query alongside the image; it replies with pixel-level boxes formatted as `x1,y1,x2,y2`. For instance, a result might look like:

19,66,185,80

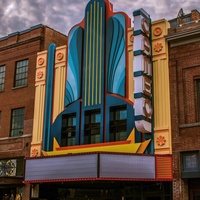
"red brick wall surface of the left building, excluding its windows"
0,26,67,200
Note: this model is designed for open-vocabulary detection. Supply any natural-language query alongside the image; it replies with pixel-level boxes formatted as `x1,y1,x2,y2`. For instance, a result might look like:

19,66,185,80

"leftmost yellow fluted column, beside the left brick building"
30,51,47,157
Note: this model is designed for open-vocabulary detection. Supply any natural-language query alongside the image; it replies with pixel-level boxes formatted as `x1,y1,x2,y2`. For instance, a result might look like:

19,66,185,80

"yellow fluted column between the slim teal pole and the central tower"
52,45,67,122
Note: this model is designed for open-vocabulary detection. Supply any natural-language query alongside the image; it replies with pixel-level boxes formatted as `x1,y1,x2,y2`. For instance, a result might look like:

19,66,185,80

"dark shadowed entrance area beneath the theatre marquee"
31,181,172,200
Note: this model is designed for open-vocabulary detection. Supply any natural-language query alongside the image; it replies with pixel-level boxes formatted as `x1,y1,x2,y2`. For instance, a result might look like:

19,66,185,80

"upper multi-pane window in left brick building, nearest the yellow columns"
14,60,28,87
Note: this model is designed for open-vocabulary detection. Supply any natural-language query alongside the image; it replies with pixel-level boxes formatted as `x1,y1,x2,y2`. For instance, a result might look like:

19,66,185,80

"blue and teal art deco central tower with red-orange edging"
51,0,134,145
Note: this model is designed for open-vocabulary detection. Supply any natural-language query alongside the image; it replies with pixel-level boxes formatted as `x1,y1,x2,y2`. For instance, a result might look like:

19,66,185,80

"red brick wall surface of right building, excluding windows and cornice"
169,24,200,200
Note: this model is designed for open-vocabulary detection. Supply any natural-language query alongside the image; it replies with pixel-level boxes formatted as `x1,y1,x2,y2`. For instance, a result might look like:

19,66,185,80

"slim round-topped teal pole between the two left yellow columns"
42,44,56,151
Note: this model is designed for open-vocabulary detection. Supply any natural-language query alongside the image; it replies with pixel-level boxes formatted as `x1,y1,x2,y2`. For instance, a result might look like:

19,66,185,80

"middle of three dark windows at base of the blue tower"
84,109,101,144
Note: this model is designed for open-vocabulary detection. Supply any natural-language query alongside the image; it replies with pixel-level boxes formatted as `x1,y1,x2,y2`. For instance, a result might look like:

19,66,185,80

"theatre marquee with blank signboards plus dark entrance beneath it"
24,152,172,200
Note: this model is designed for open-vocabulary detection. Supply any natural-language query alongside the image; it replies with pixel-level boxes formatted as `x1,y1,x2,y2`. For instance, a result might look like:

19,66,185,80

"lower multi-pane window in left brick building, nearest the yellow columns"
10,107,25,137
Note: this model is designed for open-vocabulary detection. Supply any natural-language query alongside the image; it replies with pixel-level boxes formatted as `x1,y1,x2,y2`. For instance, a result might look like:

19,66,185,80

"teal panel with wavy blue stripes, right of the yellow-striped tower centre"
106,14,126,96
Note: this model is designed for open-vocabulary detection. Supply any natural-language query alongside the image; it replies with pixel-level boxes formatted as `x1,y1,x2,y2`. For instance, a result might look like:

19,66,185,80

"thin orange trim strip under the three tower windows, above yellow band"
56,140,131,150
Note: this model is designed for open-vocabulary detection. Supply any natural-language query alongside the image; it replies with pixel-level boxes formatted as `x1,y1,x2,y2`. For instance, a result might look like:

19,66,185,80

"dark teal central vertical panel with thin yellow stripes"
82,0,105,107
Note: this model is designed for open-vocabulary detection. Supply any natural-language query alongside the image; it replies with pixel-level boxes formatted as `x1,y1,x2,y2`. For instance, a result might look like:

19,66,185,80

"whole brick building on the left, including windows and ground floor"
0,24,67,199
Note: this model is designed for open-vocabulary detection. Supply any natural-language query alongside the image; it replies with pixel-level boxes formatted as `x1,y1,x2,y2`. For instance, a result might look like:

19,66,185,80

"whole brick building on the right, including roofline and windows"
166,9,200,200
